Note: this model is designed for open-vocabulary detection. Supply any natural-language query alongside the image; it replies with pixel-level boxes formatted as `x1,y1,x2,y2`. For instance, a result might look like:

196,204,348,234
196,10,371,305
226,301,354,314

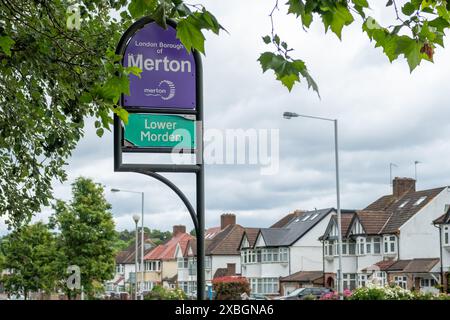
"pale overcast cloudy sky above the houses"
0,0,450,233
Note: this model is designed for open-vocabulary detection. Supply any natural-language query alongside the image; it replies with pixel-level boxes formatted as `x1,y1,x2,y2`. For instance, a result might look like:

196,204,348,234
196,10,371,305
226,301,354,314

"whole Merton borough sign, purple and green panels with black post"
114,17,205,300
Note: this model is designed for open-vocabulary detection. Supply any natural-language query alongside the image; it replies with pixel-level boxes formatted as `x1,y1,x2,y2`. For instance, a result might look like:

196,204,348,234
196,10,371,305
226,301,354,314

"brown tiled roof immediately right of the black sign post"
205,224,257,255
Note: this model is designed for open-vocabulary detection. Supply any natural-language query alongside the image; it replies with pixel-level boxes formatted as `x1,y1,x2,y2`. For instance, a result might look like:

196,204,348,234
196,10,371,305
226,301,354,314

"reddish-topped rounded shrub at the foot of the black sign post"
212,276,250,300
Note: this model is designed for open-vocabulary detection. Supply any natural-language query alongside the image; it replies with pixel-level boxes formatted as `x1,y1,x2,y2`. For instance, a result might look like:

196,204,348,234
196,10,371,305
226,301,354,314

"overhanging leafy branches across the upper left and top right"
0,0,450,226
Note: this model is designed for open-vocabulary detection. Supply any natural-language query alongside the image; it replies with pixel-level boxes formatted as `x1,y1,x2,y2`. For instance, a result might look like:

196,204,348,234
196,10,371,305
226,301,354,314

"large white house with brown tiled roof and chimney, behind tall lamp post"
321,178,450,291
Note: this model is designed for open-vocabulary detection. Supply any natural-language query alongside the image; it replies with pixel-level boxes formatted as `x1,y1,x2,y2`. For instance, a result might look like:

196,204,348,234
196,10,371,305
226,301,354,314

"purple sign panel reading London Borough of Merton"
123,22,196,110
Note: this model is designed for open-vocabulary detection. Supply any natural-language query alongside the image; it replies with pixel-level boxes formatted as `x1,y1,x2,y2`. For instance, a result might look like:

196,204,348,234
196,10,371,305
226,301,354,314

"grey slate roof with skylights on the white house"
260,208,334,247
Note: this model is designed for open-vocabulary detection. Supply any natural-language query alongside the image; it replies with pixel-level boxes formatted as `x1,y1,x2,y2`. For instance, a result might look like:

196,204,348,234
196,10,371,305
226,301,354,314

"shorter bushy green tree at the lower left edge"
0,222,59,299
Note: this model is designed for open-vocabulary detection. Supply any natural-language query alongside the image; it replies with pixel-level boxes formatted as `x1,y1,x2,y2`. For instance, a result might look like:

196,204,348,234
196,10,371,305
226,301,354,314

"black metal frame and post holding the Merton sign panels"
114,17,205,300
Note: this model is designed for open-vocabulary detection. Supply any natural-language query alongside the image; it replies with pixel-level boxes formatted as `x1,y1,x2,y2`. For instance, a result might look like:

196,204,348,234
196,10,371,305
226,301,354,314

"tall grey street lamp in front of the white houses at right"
283,112,344,297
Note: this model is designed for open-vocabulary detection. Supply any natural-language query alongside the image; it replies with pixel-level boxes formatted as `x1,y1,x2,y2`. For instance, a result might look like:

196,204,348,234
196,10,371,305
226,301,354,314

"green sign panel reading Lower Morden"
124,113,196,150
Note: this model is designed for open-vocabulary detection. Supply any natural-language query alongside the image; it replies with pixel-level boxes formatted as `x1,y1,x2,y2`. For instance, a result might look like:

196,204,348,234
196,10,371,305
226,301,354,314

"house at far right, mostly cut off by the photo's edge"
433,206,450,292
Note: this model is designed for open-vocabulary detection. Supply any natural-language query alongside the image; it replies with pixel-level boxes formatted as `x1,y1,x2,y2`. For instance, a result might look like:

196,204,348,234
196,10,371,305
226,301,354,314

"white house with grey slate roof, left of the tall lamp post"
240,208,335,295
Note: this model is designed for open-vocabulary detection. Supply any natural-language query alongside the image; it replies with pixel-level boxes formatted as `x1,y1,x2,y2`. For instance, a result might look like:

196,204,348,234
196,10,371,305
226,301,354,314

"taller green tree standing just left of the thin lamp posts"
51,178,116,299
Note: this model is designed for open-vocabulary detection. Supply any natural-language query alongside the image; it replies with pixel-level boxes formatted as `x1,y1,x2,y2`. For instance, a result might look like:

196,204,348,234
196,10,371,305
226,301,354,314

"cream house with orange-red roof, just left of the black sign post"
142,225,193,292
